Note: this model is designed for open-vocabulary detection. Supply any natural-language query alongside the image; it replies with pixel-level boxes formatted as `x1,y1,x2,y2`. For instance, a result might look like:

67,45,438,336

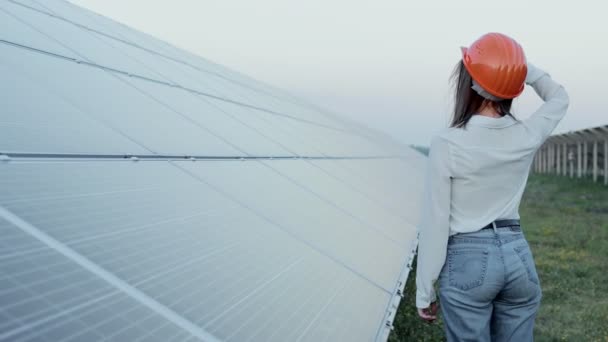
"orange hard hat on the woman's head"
461,33,528,99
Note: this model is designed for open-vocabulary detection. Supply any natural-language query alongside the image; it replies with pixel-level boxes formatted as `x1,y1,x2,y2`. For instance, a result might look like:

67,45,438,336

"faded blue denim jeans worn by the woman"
438,227,542,342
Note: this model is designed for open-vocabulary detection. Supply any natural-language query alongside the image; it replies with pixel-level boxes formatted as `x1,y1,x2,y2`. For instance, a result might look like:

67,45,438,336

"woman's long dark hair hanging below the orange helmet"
450,60,517,128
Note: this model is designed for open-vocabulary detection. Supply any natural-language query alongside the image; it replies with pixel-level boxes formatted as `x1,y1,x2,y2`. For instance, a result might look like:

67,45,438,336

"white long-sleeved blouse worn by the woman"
416,64,569,308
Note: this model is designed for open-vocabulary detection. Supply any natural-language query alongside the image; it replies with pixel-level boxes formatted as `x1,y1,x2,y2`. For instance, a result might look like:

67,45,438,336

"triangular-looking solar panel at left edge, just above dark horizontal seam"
0,59,148,154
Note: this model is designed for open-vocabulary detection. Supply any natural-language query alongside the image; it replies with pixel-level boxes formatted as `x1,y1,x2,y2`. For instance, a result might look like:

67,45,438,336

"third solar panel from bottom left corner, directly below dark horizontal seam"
180,161,409,291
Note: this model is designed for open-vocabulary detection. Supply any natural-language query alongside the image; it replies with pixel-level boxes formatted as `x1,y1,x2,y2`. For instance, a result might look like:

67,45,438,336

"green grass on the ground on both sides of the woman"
389,175,608,342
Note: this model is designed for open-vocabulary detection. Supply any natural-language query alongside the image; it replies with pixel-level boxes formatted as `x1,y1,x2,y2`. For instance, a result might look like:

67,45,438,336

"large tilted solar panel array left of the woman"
0,0,425,341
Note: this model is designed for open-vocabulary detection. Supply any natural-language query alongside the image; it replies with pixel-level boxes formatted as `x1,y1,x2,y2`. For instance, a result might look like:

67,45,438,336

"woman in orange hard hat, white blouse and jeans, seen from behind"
416,33,569,342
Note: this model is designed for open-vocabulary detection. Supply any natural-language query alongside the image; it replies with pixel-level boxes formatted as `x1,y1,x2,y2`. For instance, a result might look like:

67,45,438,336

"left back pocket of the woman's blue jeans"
448,247,489,290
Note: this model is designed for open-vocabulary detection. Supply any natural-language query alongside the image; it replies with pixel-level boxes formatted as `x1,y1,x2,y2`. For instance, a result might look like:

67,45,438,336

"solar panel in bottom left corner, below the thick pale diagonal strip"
0,219,196,341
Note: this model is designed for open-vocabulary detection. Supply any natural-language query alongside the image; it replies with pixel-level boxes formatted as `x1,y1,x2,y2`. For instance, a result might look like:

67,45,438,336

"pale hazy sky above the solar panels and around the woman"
71,0,608,145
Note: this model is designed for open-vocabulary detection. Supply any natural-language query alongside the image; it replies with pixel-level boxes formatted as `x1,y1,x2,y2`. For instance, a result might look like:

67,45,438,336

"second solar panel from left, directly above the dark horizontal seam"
0,44,239,156
